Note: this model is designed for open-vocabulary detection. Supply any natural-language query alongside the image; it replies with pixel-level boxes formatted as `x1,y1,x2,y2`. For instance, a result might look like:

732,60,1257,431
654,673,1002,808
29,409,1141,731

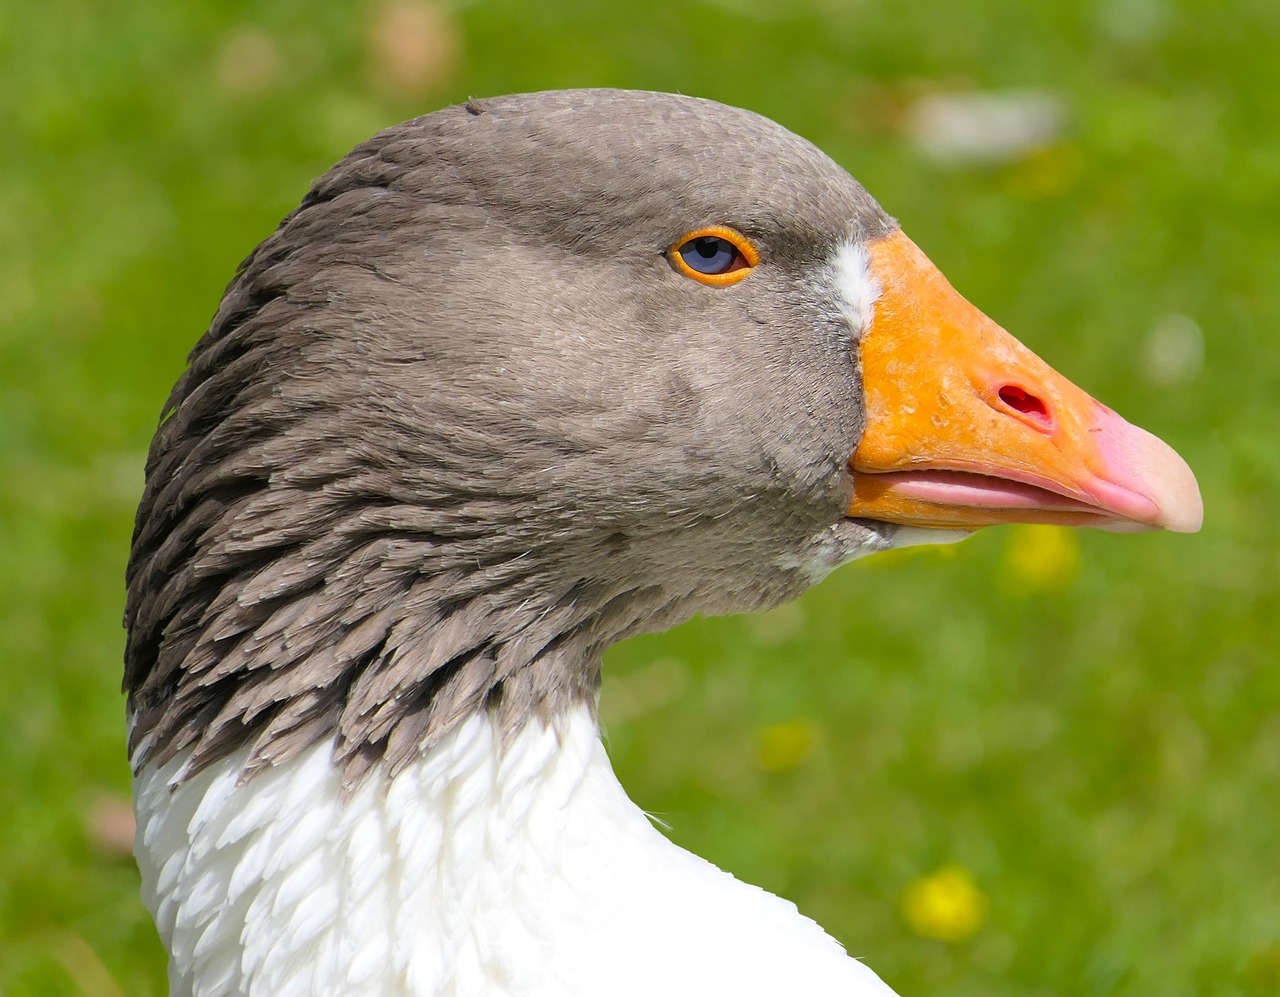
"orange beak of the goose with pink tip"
849,232,1203,532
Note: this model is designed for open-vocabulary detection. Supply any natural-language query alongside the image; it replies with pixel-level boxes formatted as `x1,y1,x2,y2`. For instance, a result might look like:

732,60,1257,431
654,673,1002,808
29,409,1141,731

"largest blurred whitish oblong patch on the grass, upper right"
906,91,1066,164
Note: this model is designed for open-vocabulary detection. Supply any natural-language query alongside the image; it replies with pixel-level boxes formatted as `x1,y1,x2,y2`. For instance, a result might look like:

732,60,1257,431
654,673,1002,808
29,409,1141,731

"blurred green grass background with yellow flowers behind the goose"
0,0,1280,997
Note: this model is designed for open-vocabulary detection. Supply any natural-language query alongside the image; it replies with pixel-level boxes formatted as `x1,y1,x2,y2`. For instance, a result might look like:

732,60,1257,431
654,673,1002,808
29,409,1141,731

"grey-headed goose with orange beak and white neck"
124,91,1202,997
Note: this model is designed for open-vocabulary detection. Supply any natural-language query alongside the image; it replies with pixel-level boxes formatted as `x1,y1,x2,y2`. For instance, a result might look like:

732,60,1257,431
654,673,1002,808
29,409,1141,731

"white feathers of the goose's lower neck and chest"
134,710,891,997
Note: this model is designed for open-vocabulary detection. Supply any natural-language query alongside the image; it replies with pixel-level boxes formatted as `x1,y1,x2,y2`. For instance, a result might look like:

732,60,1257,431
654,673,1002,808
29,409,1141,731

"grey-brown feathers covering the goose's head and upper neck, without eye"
124,91,892,779
